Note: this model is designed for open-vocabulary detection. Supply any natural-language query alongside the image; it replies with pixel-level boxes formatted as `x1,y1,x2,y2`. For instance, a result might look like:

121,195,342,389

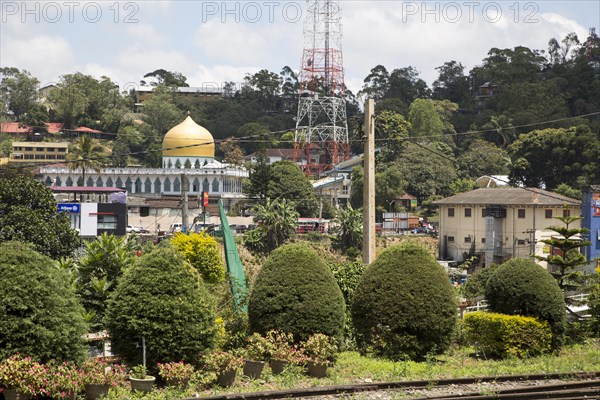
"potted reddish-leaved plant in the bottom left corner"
0,354,46,400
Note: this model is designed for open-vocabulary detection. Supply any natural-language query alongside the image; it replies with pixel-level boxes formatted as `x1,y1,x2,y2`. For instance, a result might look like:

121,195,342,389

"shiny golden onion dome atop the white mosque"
163,116,215,158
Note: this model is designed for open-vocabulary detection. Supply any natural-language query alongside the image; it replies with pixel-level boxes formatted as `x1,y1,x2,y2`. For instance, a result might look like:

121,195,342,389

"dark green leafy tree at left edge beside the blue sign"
0,176,79,260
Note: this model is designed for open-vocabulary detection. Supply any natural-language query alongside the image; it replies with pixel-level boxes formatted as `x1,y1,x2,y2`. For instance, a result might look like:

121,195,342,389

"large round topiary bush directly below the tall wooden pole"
352,243,458,360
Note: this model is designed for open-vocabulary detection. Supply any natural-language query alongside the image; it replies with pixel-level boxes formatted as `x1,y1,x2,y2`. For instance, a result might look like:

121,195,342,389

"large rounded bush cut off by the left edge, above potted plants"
0,241,87,361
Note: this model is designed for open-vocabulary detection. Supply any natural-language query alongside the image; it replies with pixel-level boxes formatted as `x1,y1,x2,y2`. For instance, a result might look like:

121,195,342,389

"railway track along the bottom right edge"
191,372,600,400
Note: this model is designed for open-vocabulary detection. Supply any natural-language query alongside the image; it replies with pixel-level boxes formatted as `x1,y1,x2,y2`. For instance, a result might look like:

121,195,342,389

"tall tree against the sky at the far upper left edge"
0,67,40,121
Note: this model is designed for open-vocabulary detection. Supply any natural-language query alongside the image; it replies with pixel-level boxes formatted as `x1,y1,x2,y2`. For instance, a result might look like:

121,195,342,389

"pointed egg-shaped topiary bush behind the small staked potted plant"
106,247,215,365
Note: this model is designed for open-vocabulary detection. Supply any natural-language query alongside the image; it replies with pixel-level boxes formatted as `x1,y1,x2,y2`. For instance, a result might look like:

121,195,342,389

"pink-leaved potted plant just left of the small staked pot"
81,359,127,400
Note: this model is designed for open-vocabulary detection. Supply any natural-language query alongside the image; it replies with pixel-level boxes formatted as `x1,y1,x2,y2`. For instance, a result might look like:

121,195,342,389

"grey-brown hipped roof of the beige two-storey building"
433,188,581,206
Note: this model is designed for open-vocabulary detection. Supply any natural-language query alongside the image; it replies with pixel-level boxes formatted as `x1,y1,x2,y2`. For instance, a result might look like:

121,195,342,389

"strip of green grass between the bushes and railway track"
104,339,600,400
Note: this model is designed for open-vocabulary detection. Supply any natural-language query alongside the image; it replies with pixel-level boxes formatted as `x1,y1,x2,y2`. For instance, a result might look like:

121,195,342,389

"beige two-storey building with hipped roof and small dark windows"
433,188,581,267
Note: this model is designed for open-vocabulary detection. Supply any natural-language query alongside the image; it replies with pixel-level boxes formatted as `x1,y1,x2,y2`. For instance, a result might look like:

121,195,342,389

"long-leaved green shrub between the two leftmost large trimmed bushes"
76,233,134,331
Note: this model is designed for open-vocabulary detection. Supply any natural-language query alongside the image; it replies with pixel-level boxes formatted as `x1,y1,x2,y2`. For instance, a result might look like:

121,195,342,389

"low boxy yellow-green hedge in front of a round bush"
464,311,552,358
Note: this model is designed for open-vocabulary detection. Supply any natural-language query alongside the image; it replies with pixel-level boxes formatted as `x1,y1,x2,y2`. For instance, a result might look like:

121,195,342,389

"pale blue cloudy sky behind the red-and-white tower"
0,0,600,93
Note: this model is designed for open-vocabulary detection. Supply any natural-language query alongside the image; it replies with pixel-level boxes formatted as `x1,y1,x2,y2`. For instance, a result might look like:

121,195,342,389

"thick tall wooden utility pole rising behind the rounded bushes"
363,99,375,265
